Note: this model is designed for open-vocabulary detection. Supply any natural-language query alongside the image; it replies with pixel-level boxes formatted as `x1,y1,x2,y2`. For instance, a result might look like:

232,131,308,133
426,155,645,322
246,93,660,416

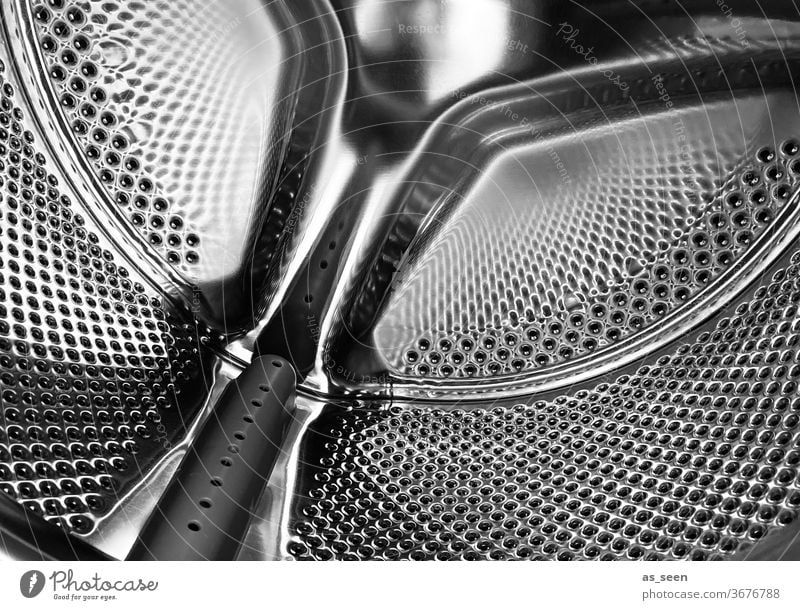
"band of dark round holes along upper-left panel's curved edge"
33,0,208,267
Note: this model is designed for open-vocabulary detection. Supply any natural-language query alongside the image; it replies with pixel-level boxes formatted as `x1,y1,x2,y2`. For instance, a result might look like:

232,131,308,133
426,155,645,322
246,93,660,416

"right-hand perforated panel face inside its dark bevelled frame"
376,89,800,379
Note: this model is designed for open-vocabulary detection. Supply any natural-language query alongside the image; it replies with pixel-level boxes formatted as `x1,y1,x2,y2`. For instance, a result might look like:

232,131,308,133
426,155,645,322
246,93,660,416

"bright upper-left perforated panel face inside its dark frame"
28,0,292,279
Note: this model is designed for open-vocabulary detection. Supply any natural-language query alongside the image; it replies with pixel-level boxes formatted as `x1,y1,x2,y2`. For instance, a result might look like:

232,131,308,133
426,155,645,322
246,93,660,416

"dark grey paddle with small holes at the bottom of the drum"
128,356,296,561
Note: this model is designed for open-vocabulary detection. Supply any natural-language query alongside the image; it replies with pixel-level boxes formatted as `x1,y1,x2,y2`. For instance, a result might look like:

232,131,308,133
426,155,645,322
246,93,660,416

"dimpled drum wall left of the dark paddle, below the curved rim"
0,60,209,534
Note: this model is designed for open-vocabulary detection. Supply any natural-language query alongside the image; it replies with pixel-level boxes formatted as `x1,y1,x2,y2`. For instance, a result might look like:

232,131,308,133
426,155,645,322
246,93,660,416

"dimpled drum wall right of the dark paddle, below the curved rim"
287,253,800,560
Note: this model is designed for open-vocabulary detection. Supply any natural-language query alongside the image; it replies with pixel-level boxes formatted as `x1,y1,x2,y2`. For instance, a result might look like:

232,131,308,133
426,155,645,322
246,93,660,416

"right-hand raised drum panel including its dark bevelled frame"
314,8,796,396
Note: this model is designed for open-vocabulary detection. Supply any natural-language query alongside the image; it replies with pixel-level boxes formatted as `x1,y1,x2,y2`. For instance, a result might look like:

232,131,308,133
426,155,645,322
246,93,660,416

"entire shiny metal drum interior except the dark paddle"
0,0,800,559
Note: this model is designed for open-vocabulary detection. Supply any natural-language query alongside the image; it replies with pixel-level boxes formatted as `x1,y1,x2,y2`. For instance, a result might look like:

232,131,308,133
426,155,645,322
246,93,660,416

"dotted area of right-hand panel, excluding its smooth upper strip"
378,94,800,378
